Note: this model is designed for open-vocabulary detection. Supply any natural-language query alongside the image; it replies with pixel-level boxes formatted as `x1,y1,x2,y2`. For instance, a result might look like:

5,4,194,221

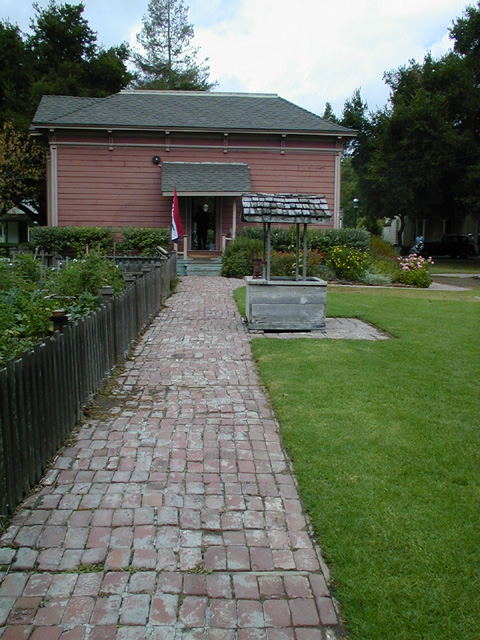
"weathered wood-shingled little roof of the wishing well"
242,193,332,224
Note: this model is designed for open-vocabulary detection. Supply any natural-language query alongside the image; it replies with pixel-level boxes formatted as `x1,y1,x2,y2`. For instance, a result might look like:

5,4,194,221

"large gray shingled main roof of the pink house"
32,91,355,137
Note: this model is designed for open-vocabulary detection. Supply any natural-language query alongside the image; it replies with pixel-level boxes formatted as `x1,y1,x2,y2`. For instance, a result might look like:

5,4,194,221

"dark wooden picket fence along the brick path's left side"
0,254,176,516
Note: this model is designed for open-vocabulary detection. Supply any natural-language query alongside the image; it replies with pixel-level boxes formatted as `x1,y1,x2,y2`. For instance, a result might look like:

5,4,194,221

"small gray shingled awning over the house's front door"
162,162,252,196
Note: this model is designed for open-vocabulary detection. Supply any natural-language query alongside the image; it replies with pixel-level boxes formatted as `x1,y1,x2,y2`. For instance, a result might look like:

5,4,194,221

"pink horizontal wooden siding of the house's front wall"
49,132,339,235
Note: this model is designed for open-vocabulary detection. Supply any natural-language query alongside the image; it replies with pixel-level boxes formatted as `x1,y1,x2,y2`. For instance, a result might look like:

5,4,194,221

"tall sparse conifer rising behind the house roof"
134,0,215,91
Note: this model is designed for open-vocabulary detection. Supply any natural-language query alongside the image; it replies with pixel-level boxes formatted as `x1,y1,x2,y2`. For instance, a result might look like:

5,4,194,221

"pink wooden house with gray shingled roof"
32,90,355,251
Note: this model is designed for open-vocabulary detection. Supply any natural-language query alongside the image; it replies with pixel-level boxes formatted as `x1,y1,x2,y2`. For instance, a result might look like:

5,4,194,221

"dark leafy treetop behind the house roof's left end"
0,0,132,130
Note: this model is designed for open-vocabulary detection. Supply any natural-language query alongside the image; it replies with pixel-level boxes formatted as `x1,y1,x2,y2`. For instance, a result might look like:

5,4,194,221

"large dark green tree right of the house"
334,2,480,241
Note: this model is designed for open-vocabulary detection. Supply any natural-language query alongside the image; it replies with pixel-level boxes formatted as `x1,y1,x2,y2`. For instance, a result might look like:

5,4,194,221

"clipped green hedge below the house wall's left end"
30,227,114,255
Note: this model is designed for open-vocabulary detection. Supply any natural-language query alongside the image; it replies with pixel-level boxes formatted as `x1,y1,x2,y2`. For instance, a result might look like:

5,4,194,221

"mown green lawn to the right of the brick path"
242,287,480,640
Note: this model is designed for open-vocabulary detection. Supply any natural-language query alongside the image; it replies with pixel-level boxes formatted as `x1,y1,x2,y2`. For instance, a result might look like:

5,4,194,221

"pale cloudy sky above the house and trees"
0,0,474,115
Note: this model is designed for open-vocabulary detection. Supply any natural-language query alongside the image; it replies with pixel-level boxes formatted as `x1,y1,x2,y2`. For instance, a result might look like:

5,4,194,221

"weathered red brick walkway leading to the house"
0,277,341,640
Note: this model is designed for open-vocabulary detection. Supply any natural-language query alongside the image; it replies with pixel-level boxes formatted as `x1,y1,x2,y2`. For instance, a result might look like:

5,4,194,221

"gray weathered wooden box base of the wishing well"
245,276,327,331
